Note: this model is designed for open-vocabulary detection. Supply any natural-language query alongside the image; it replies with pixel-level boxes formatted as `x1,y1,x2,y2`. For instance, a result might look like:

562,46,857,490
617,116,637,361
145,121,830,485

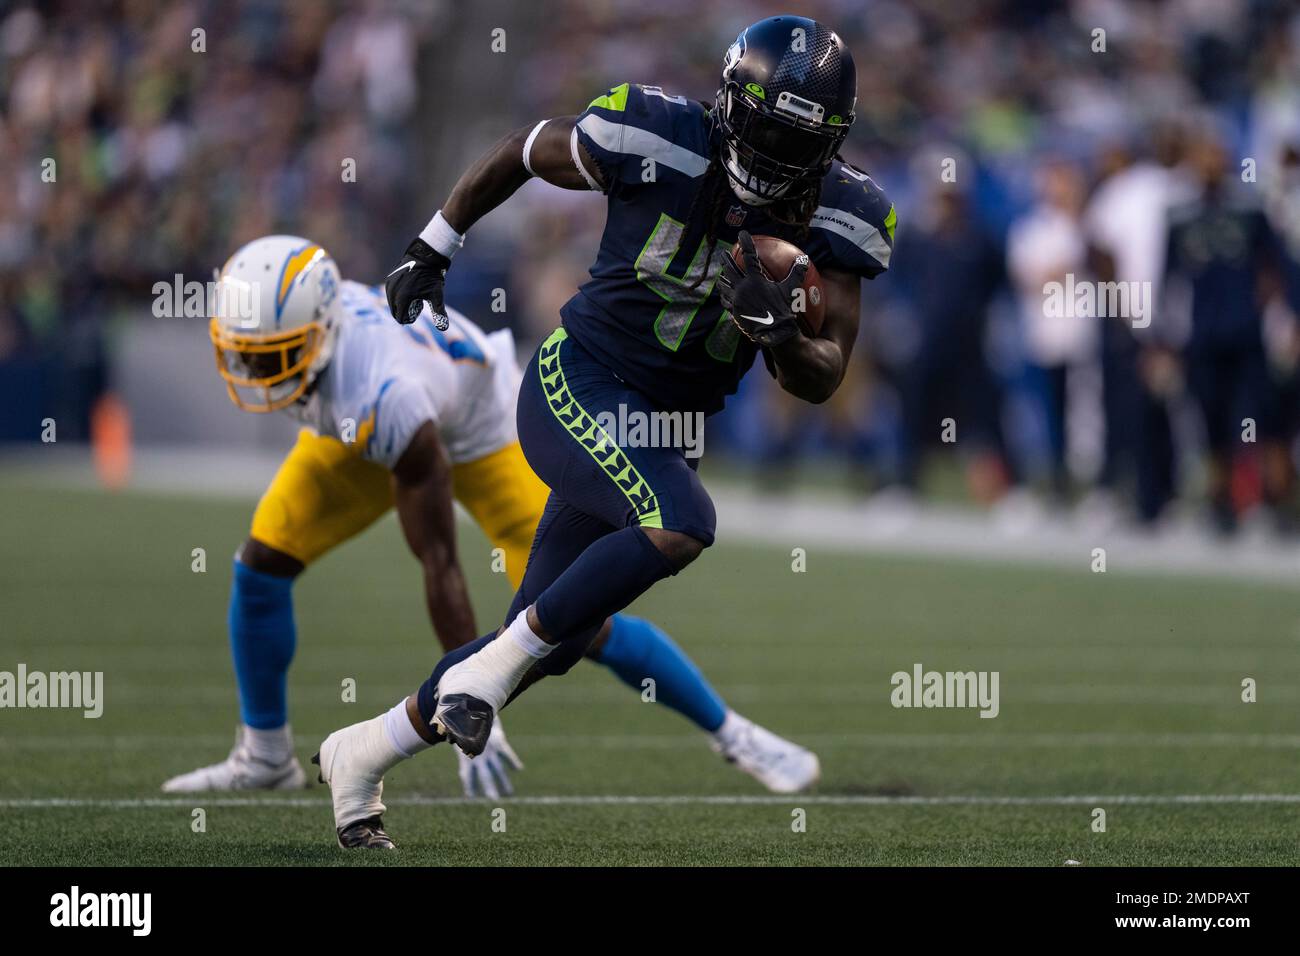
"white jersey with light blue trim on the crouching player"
293,281,520,468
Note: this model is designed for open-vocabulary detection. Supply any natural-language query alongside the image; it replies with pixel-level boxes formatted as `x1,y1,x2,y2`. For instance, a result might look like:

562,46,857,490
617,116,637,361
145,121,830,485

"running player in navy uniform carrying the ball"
319,17,894,847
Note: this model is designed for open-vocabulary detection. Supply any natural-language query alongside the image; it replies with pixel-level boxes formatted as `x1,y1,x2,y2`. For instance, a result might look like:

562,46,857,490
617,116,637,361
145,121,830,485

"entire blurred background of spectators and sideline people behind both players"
0,0,1300,529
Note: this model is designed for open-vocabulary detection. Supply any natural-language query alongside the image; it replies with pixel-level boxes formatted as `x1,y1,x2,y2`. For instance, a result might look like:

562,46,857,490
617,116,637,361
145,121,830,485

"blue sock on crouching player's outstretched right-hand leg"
597,614,727,734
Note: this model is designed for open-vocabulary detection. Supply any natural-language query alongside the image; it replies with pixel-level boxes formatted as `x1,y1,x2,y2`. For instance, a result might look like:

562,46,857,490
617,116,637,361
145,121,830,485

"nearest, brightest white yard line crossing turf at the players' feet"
0,793,1300,810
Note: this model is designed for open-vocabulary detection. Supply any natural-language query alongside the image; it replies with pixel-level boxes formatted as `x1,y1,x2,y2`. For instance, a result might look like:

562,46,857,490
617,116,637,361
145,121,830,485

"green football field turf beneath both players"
0,485,1300,865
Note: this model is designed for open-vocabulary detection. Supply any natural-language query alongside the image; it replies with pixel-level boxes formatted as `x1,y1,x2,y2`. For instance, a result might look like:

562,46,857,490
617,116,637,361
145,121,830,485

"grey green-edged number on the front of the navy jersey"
636,213,740,362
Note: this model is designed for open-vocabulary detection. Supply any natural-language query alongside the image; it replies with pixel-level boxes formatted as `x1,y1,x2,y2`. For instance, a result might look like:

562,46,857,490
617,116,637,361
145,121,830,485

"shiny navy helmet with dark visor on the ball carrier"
714,17,858,206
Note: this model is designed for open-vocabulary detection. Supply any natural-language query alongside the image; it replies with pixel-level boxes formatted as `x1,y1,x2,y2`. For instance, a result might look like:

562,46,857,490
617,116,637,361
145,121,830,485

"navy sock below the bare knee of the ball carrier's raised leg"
534,524,676,643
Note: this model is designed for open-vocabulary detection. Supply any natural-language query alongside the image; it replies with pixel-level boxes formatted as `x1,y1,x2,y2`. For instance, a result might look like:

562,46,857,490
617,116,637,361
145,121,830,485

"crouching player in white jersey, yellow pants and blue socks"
163,235,819,811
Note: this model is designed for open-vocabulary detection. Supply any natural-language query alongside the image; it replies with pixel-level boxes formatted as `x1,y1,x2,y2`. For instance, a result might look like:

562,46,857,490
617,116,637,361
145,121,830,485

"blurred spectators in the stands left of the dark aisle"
0,0,439,438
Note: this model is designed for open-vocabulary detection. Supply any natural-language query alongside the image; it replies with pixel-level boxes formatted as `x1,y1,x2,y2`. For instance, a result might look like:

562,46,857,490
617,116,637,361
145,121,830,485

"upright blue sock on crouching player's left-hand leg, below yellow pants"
229,559,298,730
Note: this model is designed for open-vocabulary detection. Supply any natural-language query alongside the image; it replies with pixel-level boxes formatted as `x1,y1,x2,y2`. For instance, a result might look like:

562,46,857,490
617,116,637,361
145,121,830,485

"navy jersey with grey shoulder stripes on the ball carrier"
560,83,894,414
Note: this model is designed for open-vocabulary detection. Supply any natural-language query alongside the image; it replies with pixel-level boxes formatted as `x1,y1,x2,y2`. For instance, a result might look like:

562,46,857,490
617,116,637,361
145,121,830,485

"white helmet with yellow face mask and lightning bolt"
208,235,342,412
